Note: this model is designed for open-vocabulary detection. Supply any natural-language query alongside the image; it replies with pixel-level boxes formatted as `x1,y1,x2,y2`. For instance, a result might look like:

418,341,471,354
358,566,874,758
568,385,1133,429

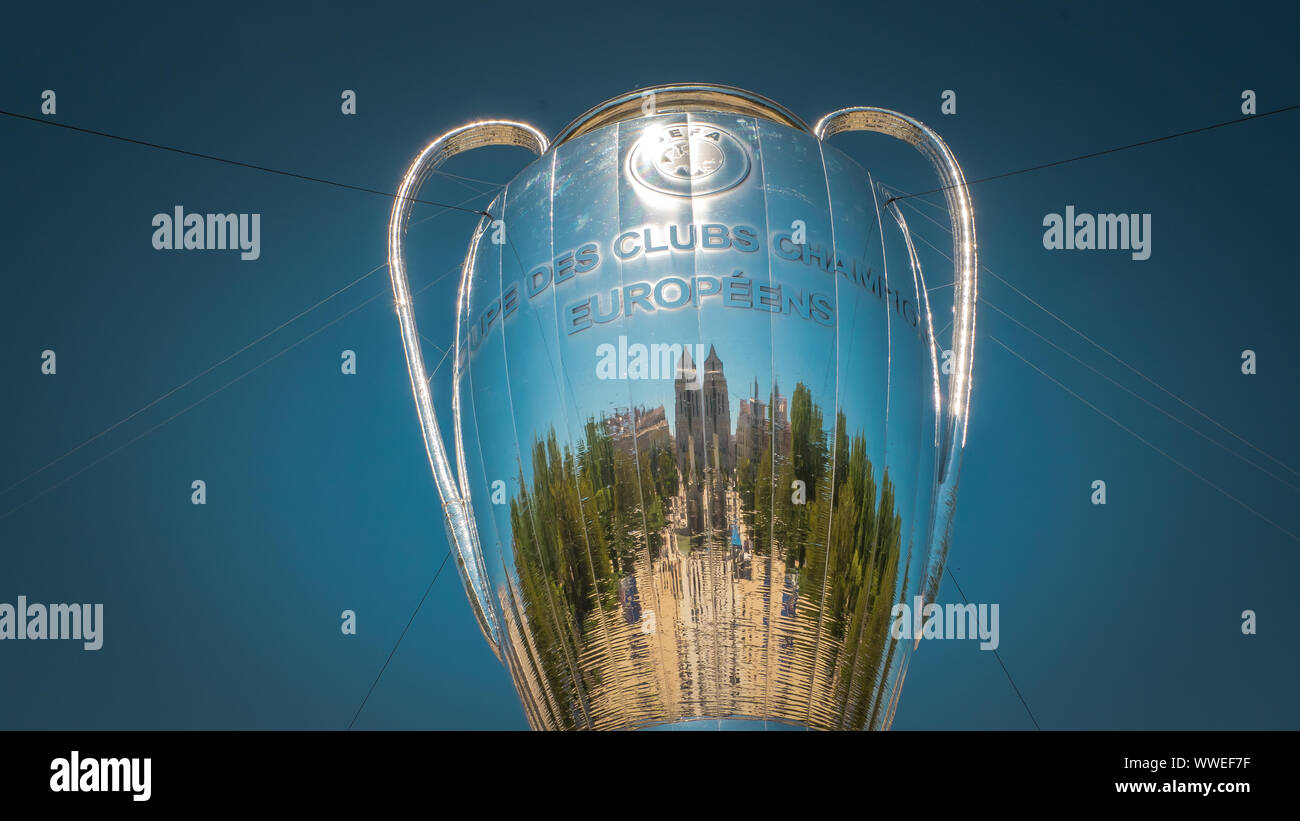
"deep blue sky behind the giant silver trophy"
0,3,1300,729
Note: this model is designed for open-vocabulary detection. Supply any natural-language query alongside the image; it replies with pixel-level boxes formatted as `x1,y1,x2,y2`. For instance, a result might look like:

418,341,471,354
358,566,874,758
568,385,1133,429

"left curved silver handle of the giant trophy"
389,120,549,657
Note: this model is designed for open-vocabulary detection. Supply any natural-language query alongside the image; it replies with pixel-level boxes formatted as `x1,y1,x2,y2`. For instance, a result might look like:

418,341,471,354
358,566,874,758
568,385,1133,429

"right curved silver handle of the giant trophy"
813,107,979,600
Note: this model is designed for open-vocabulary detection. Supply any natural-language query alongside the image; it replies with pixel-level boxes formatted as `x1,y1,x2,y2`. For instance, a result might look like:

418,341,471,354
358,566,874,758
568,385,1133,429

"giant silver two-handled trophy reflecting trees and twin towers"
389,84,976,729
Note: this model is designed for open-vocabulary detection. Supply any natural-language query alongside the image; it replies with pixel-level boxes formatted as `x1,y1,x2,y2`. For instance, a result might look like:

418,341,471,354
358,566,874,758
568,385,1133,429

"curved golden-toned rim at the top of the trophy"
550,83,816,148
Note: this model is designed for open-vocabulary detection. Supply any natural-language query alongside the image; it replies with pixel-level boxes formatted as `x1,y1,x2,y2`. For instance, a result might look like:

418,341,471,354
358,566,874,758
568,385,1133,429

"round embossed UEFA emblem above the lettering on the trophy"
628,122,750,196
